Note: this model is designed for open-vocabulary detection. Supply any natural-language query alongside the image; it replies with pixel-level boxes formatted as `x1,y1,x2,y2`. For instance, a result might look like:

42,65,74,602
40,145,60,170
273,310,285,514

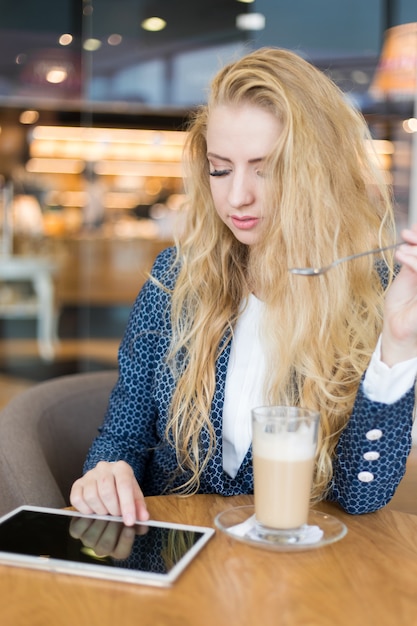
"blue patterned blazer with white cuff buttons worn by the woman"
84,248,414,513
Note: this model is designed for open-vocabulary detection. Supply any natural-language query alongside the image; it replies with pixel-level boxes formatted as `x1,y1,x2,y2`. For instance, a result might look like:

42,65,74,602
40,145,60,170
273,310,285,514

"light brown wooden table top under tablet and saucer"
0,496,417,626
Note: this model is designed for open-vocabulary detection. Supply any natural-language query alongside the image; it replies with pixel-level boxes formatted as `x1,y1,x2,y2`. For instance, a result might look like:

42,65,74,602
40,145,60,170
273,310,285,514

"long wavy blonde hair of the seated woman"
161,48,395,501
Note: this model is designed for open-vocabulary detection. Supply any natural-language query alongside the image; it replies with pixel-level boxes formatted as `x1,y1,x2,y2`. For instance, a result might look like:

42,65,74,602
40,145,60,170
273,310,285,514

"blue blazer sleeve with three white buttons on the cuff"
328,384,415,514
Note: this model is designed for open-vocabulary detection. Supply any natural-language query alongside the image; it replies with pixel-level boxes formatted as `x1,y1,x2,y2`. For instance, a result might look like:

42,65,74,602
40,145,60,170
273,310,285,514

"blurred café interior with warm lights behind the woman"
0,0,417,405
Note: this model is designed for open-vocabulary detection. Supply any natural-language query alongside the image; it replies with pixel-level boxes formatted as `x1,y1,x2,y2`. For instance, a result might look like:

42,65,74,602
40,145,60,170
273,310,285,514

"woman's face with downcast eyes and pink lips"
207,104,282,246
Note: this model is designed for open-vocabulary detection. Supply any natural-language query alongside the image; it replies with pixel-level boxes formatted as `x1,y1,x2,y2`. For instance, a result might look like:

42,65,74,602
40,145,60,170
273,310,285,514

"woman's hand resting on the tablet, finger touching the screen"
70,461,149,526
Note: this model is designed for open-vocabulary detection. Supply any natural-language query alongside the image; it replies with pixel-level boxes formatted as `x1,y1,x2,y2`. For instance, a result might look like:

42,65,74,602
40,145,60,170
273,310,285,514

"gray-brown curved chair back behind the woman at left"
0,371,117,515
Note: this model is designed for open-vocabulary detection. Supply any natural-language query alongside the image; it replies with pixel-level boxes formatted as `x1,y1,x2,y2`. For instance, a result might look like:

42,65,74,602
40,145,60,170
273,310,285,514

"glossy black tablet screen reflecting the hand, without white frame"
0,510,203,574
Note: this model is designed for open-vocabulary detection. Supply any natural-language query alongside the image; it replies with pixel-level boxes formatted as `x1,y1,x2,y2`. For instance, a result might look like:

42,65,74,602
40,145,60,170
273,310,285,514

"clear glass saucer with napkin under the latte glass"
214,506,347,552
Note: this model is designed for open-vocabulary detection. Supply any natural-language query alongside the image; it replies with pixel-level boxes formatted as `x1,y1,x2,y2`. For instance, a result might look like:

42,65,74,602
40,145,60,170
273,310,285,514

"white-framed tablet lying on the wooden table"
0,506,214,586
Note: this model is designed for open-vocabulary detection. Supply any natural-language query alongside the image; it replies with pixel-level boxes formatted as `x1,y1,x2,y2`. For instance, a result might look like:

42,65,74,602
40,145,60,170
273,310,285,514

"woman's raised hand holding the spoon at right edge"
381,224,417,367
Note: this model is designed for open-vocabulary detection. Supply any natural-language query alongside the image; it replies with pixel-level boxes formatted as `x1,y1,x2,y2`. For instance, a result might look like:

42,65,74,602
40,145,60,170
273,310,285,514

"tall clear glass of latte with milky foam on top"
252,406,319,541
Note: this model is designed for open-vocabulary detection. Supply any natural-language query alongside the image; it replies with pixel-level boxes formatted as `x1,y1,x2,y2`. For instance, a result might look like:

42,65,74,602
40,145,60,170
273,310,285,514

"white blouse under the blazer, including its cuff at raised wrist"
222,295,417,478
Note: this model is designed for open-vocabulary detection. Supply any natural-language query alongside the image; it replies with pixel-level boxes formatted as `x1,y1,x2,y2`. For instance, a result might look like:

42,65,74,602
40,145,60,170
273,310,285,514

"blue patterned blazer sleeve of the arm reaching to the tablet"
84,249,173,483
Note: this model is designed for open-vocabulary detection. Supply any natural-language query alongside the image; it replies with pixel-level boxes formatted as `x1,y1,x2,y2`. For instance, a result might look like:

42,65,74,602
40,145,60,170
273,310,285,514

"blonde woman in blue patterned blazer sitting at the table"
71,49,417,525
